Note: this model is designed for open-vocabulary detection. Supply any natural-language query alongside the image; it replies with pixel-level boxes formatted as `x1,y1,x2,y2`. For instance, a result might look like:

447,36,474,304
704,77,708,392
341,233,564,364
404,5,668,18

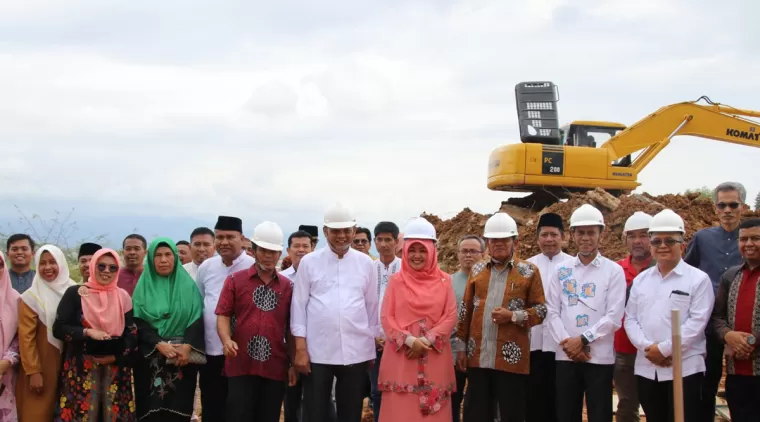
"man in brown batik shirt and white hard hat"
456,212,546,422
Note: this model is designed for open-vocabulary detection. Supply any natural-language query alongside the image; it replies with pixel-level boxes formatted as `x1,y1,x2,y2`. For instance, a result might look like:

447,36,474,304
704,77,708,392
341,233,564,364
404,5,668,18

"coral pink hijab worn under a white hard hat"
394,239,451,329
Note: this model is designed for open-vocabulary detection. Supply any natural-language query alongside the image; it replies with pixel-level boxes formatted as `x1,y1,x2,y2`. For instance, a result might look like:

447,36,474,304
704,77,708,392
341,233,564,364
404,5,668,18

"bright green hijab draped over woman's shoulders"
132,237,203,338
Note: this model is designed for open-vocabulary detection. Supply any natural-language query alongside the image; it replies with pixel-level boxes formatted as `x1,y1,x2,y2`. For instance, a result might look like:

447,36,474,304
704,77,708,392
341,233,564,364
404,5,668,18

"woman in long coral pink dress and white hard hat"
378,218,457,422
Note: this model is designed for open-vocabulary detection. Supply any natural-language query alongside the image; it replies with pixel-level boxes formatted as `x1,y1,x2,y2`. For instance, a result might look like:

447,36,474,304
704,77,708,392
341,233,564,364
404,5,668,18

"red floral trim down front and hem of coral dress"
378,319,454,415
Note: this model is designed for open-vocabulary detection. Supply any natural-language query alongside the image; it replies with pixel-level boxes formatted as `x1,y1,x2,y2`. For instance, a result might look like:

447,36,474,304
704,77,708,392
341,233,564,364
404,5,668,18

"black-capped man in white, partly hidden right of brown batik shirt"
525,213,570,422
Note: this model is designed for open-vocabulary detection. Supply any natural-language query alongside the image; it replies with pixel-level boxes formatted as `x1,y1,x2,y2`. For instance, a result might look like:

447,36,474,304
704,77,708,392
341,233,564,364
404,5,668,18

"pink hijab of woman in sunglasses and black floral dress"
82,249,132,337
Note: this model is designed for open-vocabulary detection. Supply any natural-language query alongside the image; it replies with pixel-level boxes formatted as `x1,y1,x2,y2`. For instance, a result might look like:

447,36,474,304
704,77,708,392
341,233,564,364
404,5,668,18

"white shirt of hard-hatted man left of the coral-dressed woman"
290,246,380,365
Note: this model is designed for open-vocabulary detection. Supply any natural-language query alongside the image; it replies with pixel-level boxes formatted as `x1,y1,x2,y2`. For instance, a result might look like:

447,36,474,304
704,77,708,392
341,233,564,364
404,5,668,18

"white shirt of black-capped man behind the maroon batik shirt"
195,251,253,356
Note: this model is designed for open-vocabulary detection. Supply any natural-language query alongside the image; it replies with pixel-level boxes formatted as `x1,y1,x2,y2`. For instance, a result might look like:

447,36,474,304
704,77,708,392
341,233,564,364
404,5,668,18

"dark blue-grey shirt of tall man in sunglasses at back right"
684,226,743,294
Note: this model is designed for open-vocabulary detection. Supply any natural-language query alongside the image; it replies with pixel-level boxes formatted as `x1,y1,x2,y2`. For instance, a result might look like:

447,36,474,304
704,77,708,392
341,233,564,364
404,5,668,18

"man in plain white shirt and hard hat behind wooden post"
625,209,715,421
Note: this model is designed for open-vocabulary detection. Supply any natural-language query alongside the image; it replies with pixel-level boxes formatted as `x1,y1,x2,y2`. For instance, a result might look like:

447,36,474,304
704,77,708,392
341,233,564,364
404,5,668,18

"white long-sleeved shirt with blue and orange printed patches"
544,254,626,365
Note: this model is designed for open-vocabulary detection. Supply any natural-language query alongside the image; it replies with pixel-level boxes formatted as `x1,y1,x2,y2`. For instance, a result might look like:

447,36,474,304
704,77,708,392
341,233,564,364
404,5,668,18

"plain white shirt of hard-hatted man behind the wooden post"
625,260,715,381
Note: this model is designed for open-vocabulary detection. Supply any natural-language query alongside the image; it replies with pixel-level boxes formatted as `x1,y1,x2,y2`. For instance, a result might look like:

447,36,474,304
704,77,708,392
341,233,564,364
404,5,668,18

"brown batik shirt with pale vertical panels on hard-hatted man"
455,259,546,374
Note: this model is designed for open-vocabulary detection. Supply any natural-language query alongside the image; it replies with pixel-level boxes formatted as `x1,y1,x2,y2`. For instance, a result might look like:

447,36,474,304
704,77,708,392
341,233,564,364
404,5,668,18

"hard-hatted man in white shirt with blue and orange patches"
546,204,625,422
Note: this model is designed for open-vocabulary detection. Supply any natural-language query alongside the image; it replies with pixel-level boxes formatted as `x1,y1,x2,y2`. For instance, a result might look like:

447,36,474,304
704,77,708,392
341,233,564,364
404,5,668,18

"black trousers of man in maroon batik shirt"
227,375,287,422
